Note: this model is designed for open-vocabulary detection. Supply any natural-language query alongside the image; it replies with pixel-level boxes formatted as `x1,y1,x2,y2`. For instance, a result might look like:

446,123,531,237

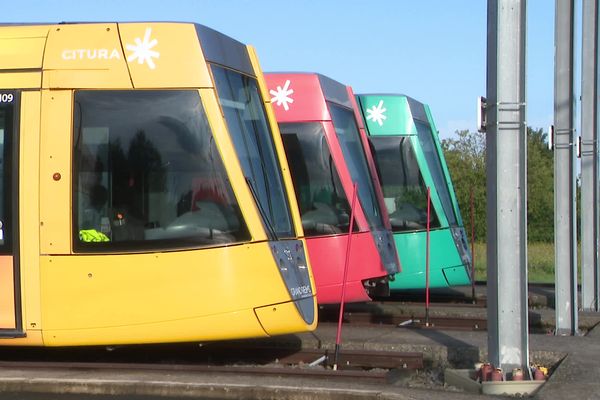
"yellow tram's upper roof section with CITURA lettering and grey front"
0,22,257,89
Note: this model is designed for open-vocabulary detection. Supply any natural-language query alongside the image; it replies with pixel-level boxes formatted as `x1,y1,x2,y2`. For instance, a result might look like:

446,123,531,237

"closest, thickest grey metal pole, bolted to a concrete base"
486,0,529,371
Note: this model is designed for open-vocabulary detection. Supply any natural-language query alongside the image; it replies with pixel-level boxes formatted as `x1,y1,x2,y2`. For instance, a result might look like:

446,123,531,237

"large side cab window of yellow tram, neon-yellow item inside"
73,90,250,251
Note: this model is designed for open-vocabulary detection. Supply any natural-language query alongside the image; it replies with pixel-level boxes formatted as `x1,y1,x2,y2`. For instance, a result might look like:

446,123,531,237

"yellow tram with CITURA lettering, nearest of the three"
0,23,316,346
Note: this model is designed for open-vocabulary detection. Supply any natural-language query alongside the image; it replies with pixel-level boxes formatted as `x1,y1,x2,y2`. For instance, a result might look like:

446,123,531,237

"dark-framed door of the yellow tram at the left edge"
0,90,20,336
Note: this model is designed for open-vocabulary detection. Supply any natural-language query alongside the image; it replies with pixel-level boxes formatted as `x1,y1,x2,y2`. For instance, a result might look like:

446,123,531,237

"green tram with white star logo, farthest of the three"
356,94,472,291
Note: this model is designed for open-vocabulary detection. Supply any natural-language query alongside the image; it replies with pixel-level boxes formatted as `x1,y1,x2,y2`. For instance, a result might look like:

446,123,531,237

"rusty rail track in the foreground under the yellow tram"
0,346,423,383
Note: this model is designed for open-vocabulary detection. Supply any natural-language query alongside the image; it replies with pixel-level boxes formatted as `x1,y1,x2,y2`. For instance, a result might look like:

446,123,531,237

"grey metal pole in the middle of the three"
554,0,578,335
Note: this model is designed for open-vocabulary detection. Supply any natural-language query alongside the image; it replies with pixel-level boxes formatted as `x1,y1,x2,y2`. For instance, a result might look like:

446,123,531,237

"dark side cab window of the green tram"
369,136,440,232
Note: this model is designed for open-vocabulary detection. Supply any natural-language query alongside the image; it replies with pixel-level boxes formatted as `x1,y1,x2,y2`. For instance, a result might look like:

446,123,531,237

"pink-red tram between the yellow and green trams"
265,73,400,304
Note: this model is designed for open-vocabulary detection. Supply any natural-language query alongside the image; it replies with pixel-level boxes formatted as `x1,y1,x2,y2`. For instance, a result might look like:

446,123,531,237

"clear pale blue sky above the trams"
0,0,554,138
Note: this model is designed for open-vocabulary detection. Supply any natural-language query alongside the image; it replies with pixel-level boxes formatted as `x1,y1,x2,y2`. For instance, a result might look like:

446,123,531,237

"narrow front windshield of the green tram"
415,120,458,226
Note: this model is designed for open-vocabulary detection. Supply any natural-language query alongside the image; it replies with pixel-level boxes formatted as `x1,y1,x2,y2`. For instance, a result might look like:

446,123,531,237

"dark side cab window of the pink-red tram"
279,122,357,236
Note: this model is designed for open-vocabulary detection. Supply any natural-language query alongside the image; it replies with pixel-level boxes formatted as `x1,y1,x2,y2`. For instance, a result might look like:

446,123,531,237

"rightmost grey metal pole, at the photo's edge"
581,0,600,311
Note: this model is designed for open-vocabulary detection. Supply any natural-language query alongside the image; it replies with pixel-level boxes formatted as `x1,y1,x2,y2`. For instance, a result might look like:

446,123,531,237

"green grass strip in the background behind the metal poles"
475,243,556,283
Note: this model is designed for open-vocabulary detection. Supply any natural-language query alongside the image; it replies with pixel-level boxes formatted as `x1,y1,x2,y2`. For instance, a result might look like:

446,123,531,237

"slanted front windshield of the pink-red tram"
328,103,385,230
